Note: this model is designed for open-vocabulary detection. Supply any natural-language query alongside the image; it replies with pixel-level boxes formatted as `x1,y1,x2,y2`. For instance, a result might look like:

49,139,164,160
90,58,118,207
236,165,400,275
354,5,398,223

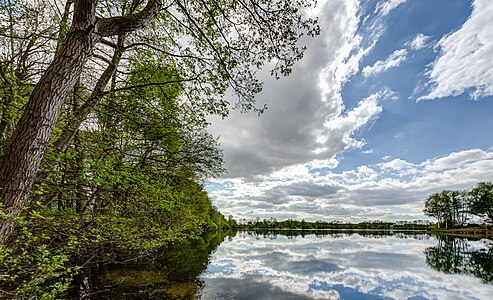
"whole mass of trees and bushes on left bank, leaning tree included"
0,0,319,299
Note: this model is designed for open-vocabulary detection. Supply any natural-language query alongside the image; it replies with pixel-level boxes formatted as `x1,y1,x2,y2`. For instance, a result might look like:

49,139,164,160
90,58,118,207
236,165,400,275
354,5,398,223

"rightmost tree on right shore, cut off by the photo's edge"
469,182,493,223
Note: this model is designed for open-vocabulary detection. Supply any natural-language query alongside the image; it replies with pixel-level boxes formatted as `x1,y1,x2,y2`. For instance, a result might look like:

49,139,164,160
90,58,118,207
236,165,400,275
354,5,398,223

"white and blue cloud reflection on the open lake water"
201,232,493,299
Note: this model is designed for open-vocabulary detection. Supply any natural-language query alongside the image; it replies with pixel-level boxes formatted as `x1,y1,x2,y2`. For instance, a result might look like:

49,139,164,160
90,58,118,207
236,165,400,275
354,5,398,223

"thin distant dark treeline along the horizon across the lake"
235,219,430,230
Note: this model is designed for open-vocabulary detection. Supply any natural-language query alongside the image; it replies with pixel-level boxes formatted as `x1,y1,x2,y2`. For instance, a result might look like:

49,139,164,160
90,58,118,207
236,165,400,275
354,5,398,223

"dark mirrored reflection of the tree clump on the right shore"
424,235,493,284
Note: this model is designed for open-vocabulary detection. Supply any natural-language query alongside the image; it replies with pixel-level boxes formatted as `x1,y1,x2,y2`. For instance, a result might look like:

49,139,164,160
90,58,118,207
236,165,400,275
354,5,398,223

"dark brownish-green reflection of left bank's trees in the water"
67,234,232,300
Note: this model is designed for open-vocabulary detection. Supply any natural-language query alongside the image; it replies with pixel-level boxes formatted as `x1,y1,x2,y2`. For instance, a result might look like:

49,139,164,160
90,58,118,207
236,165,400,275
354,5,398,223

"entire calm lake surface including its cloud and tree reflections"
74,231,493,300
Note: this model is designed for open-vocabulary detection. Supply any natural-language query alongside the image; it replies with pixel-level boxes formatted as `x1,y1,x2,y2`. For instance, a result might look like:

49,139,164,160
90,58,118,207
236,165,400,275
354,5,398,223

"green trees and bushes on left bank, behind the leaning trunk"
0,56,229,299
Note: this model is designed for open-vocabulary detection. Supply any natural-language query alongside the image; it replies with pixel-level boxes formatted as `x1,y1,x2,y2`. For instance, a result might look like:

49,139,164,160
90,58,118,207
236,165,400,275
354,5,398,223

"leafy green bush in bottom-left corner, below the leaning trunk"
0,209,78,299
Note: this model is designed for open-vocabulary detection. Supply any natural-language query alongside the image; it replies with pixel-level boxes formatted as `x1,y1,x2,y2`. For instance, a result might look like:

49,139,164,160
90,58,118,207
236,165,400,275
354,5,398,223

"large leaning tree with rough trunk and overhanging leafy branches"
0,0,319,242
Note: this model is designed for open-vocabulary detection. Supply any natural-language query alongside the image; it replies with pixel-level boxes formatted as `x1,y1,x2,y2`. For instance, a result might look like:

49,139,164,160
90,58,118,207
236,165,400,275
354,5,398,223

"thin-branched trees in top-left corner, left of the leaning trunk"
0,0,56,152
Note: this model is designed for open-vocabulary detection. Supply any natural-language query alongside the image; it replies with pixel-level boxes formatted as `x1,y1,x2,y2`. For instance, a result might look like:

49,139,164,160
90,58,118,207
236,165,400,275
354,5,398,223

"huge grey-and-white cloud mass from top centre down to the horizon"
208,0,493,221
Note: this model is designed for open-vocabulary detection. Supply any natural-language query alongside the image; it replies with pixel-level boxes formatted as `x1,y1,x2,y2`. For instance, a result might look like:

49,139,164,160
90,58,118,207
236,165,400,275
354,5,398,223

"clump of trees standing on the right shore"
424,182,493,229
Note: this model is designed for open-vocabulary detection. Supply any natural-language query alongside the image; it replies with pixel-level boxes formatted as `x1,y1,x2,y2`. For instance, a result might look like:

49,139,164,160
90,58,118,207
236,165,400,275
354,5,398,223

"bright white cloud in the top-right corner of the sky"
419,0,493,100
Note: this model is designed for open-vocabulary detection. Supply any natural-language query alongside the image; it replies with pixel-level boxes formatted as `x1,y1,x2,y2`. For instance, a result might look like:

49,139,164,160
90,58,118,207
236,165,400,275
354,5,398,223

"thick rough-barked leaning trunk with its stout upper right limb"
0,0,161,242
